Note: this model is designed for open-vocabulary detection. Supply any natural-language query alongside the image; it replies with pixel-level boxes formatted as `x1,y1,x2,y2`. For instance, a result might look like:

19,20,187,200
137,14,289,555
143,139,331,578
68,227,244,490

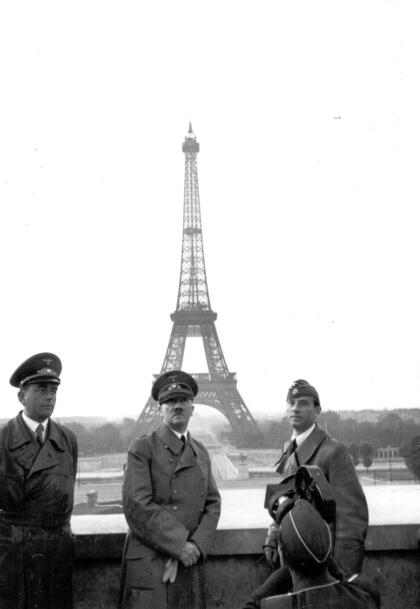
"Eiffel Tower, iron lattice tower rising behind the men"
137,123,259,434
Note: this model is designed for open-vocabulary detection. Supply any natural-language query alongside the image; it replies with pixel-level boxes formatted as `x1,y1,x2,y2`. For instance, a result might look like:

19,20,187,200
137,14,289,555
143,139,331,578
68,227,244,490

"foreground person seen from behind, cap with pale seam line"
261,499,380,609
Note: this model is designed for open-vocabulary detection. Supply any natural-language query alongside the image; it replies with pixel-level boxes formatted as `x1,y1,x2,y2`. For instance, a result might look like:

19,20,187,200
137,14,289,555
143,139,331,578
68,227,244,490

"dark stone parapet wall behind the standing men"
74,525,420,609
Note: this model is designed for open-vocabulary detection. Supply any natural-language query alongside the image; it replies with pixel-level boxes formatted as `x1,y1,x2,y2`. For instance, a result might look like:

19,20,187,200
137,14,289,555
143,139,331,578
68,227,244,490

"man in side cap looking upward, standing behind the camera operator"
240,379,369,609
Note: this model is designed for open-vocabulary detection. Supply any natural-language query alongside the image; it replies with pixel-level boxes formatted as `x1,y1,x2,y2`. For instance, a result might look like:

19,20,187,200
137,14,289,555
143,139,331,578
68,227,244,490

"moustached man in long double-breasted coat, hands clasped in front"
122,370,220,609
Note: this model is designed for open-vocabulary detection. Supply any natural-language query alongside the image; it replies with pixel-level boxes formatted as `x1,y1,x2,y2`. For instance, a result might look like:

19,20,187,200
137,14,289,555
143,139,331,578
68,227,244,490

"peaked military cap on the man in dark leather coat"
10,353,62,387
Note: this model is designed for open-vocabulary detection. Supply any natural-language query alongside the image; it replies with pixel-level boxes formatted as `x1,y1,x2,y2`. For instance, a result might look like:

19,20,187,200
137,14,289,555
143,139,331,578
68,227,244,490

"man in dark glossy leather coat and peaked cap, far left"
0,353,77,609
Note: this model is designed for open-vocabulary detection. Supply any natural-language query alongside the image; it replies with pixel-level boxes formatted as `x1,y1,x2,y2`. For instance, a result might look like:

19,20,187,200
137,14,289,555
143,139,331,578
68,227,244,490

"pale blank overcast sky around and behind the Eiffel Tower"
0,0,420,417
